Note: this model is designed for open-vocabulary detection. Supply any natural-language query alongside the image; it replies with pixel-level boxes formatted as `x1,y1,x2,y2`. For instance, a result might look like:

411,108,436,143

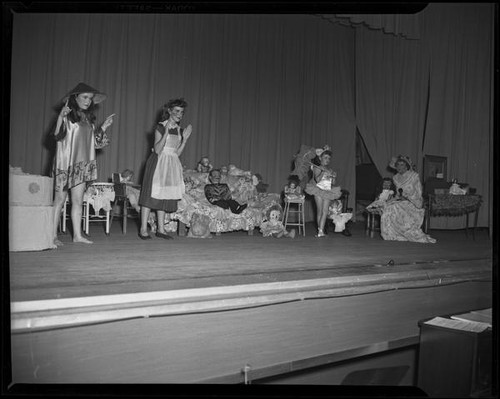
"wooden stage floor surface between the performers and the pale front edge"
9,222,492,301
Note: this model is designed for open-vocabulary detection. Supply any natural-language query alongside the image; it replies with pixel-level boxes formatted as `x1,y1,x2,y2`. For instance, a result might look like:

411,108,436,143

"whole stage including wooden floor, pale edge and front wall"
10,221,492,384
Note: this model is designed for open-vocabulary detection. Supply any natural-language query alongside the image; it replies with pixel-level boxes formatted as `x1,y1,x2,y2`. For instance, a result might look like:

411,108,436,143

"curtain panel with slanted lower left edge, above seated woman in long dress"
356,26,428,181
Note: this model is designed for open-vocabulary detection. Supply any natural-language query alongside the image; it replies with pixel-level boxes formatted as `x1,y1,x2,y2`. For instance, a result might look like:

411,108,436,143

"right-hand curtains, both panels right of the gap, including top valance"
329,3,495,231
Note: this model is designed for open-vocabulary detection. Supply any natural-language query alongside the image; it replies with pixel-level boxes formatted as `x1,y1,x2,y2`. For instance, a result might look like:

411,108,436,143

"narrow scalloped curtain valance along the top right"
322,13,421,39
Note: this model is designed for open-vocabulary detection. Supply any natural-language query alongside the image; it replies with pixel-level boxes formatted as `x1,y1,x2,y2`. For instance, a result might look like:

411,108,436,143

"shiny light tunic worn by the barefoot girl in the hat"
52,116,108,191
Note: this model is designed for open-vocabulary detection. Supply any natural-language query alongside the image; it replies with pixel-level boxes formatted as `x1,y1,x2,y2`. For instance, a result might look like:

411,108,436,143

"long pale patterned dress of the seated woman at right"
380,170,436,243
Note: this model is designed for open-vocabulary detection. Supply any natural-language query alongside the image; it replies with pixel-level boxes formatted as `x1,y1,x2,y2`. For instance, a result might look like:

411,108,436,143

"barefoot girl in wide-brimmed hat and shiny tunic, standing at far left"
53,83,114,246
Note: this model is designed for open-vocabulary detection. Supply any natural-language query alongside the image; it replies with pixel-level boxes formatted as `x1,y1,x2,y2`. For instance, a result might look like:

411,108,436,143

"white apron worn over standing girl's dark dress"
151,125,186,200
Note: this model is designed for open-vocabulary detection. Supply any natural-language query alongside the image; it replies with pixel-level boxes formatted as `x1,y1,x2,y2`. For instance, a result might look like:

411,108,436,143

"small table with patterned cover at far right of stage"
425,194,483,240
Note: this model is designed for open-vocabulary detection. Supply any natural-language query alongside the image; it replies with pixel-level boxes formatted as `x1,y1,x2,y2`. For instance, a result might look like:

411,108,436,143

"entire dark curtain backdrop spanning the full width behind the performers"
10,3,494,226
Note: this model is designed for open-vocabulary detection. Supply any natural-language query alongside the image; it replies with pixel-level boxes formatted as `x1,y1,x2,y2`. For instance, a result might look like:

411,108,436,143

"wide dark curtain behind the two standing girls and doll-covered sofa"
10,13,356,205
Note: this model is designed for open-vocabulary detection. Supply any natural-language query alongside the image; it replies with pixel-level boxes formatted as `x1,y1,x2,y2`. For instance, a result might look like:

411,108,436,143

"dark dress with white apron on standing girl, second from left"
139,121,186,212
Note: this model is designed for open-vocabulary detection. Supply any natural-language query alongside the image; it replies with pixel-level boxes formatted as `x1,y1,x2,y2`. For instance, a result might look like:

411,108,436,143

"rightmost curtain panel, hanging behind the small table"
422,4,495,228
